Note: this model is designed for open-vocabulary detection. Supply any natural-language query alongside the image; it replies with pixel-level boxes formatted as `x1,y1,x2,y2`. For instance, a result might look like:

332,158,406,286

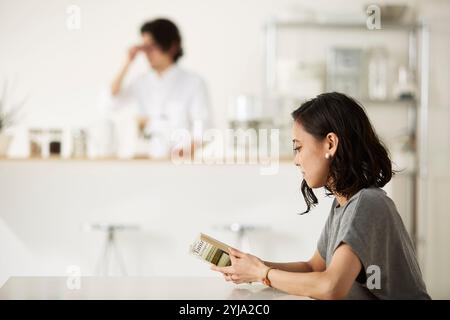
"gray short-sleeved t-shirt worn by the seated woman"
317,188,430,299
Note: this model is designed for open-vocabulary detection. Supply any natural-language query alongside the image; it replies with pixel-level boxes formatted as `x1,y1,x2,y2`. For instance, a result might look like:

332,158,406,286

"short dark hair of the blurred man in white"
141,19,183,62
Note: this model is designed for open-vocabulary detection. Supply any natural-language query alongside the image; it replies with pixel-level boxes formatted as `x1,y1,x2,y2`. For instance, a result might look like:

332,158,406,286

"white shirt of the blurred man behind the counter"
107,65,210,155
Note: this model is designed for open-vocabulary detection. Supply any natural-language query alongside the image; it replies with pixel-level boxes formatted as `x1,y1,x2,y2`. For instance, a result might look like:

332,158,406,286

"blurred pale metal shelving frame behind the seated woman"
263,20,429,247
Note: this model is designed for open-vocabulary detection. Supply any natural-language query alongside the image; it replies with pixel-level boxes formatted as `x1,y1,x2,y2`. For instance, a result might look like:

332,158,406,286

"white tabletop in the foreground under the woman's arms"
0,277,309,300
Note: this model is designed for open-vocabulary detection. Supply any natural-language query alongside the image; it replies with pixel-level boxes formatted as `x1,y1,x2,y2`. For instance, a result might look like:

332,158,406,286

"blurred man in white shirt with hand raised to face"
110,19,210,157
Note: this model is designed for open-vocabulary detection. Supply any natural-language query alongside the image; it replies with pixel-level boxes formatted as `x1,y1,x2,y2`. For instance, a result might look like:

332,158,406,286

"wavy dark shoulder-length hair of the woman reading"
292,92,395,213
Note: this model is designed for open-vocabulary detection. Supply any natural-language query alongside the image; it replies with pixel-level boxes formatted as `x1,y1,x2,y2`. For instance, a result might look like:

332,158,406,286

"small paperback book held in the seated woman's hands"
190,233,231,267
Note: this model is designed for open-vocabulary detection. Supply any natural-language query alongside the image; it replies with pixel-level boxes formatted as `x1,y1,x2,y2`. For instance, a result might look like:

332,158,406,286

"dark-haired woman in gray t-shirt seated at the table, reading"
212,92,430,299
